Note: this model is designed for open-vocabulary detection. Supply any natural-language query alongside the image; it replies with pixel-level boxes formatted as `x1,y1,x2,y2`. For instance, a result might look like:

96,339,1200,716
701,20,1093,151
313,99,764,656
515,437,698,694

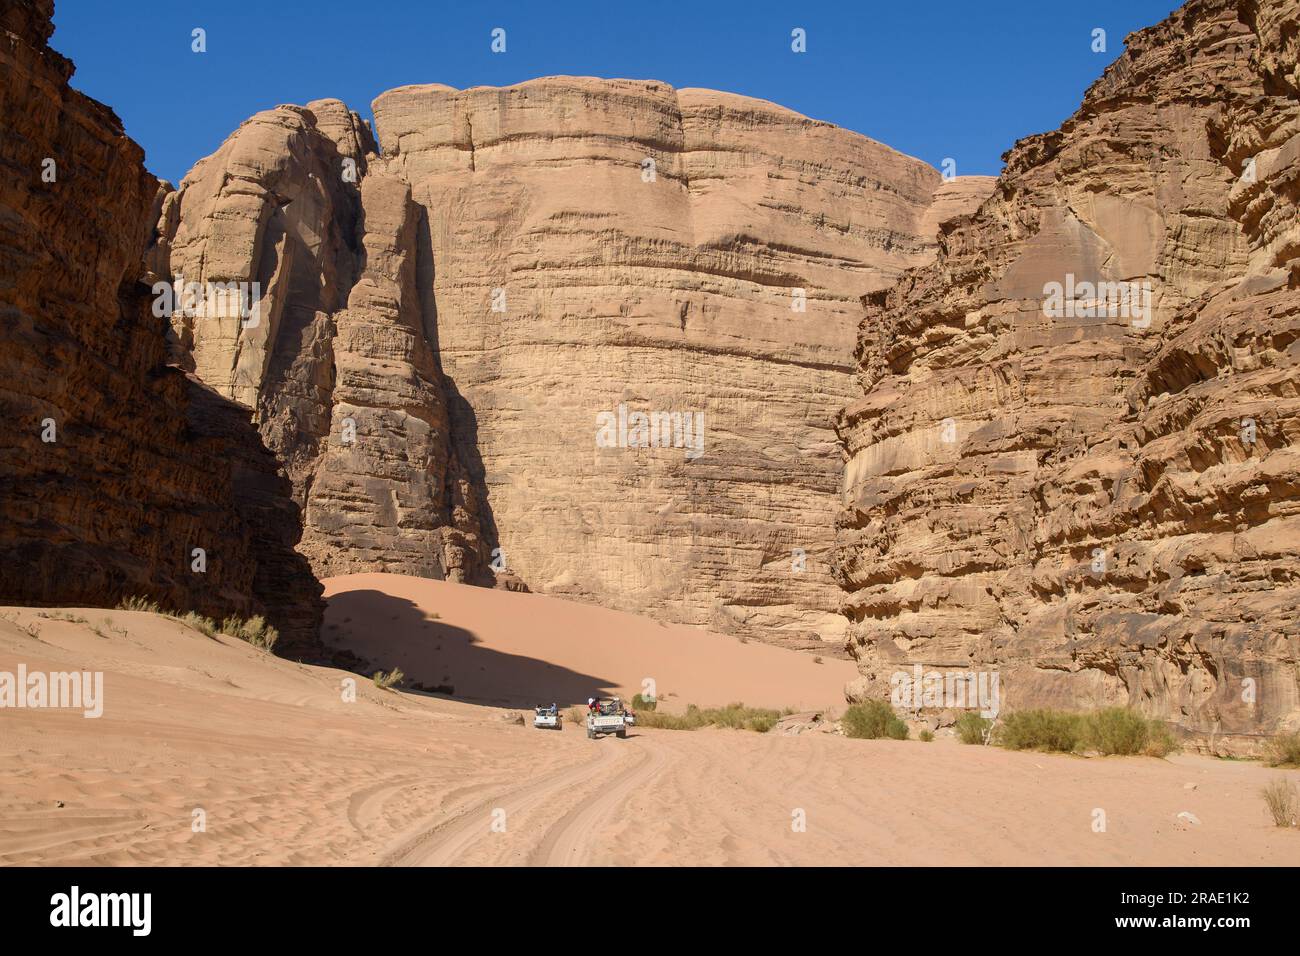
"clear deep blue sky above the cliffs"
51,0,1178,182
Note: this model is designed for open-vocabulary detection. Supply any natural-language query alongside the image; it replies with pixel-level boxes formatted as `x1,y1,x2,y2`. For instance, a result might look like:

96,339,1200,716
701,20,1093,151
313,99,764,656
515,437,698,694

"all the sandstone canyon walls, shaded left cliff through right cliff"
0,0,1300,737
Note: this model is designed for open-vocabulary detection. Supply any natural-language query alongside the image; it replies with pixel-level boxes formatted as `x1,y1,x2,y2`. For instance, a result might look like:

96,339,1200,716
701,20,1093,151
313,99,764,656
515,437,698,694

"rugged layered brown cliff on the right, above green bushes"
835,0,1300,736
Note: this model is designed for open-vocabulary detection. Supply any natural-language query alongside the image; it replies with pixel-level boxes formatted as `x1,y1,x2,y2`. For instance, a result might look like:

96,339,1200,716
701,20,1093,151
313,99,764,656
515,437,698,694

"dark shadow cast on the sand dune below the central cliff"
322,591,615,708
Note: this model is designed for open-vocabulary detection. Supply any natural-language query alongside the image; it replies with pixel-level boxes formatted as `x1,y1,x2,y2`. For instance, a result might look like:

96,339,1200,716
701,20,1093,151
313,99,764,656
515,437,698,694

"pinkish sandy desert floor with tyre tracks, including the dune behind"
0,575,1300,866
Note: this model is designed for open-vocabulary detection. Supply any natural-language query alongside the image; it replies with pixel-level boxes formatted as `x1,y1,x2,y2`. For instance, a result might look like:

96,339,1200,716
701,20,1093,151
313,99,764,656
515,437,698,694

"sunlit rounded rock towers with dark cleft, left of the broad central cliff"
151,100,486,581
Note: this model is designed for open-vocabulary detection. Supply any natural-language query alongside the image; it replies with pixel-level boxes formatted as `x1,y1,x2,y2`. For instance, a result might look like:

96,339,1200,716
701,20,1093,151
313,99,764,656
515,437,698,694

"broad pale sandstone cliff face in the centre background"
374,77,982,644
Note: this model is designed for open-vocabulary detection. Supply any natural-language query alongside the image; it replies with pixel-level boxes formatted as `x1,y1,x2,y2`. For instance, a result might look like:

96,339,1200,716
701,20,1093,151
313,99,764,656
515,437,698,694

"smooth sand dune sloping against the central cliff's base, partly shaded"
325,574,858,709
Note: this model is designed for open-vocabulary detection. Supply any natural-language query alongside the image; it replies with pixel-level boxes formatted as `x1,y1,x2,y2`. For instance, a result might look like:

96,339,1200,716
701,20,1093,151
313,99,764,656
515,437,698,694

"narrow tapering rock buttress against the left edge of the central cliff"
303,172,482,581
